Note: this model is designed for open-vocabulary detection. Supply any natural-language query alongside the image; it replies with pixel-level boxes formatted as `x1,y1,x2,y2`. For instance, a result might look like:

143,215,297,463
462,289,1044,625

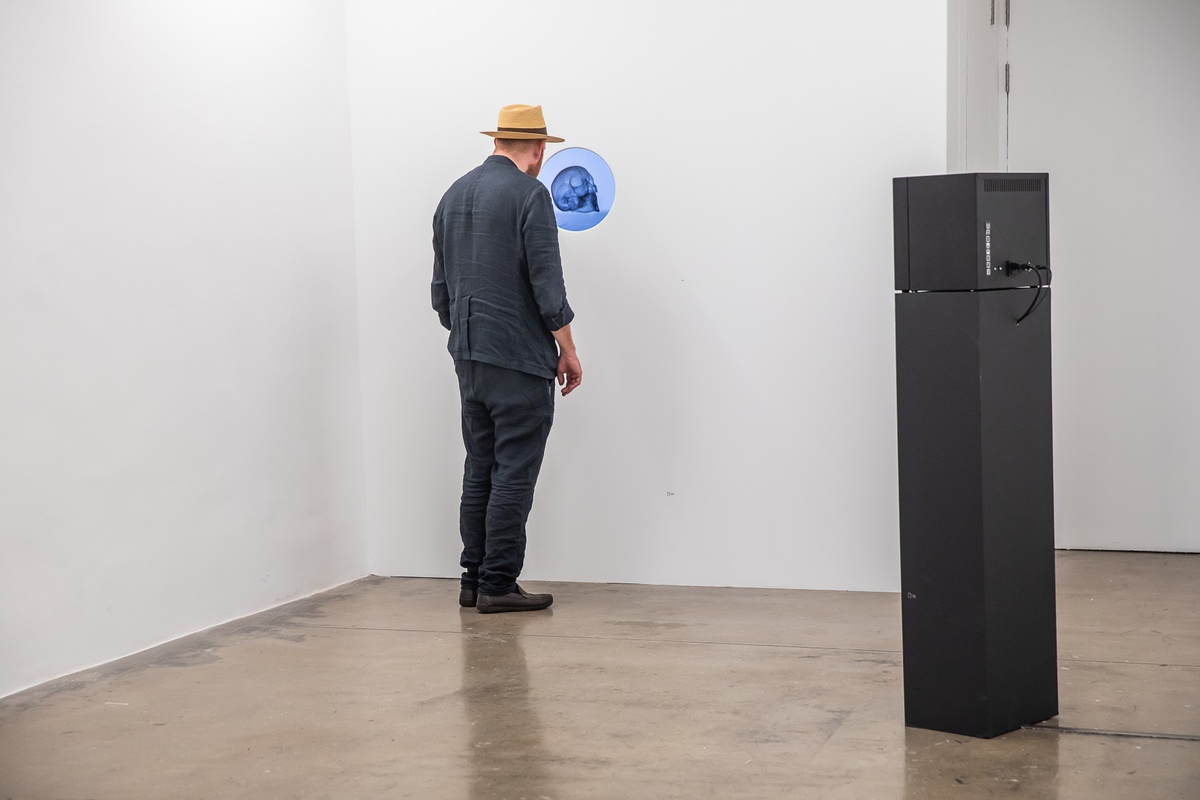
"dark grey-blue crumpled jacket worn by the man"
432,156,575,378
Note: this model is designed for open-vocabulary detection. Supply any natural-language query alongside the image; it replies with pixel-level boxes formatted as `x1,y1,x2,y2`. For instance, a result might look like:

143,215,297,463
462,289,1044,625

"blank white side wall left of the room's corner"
0,0,366,696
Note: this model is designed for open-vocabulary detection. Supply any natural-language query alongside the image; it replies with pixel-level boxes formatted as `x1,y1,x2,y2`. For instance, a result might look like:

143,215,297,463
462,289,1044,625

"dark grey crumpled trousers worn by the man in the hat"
455,361,554,595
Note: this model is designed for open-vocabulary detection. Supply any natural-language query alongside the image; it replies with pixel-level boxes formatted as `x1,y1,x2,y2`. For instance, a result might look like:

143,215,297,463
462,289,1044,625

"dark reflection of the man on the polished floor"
462,614,551,800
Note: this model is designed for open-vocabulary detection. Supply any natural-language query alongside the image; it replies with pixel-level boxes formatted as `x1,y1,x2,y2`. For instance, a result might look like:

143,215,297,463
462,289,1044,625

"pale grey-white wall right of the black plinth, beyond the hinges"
1008,0,1200,552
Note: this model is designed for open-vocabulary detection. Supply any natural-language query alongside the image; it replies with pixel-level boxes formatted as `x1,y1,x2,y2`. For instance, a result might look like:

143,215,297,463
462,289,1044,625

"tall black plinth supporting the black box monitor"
896,289,1058,738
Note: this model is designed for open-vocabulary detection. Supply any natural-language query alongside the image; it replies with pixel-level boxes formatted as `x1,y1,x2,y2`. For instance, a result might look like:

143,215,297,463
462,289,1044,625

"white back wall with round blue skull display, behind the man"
347,0,947,590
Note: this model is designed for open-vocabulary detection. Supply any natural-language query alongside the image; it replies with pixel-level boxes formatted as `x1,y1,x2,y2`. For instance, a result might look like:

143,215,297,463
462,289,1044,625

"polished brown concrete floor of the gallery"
0,553,1200,800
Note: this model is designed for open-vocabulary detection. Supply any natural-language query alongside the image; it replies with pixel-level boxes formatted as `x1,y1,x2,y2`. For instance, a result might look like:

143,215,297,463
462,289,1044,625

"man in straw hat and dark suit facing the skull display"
432,106,583,614
